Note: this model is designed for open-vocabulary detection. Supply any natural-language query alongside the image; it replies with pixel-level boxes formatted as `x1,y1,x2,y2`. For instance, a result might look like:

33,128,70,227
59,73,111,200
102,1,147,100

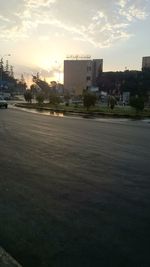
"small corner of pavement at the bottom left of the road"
0,247,21,267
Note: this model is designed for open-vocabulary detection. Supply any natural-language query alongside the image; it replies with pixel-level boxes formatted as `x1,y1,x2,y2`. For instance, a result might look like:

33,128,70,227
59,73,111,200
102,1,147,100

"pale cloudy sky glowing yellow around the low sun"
0,0,150,84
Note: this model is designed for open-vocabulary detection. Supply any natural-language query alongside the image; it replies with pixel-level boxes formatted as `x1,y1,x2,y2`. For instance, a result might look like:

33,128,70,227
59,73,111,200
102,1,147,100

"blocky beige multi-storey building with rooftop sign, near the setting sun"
64,59,103,95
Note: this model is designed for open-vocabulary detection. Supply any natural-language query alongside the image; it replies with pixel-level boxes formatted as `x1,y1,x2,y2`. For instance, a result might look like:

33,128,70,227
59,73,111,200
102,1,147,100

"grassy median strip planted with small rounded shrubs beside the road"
17,94,150,118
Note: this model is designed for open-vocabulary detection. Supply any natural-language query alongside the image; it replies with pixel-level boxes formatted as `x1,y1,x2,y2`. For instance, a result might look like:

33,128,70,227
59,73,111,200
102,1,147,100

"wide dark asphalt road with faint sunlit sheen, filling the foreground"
0,109,150,267
